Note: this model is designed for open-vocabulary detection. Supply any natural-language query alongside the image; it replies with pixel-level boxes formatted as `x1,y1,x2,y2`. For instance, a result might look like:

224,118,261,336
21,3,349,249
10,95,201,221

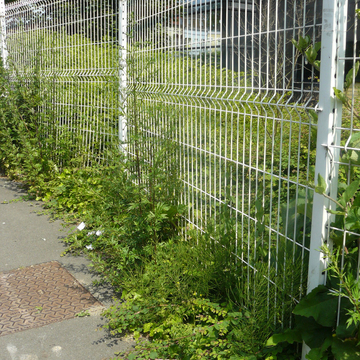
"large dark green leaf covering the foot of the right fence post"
293,285,337,327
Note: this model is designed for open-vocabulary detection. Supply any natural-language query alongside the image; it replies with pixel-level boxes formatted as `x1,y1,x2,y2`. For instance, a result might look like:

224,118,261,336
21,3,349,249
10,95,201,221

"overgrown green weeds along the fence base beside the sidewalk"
0,36,306,360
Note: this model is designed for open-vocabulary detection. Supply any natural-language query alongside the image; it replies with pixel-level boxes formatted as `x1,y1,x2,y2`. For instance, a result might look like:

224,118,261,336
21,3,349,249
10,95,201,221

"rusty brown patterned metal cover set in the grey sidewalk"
0,261,103,336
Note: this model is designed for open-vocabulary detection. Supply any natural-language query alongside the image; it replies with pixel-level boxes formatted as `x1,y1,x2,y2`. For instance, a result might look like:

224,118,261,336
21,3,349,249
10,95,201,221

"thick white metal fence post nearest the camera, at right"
302,0,348,359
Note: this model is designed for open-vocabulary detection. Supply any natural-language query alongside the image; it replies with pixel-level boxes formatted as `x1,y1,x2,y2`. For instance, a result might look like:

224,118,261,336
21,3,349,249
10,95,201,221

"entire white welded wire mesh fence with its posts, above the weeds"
6,0,359,340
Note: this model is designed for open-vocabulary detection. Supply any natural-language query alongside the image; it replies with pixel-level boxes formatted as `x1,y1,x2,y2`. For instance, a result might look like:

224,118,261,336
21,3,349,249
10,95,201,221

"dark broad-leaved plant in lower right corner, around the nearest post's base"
267,169,360,360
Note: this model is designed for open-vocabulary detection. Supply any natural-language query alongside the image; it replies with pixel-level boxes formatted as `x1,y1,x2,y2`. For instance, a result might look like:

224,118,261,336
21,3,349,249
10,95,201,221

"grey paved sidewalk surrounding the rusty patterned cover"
0,178,133,360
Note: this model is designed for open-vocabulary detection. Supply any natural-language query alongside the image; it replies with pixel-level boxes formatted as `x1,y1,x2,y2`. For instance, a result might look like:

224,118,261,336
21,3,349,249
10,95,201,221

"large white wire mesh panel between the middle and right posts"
128,0,322,326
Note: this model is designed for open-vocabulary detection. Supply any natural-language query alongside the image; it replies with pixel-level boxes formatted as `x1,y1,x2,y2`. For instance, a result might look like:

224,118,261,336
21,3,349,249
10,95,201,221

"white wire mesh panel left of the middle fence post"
6,0,119,164
